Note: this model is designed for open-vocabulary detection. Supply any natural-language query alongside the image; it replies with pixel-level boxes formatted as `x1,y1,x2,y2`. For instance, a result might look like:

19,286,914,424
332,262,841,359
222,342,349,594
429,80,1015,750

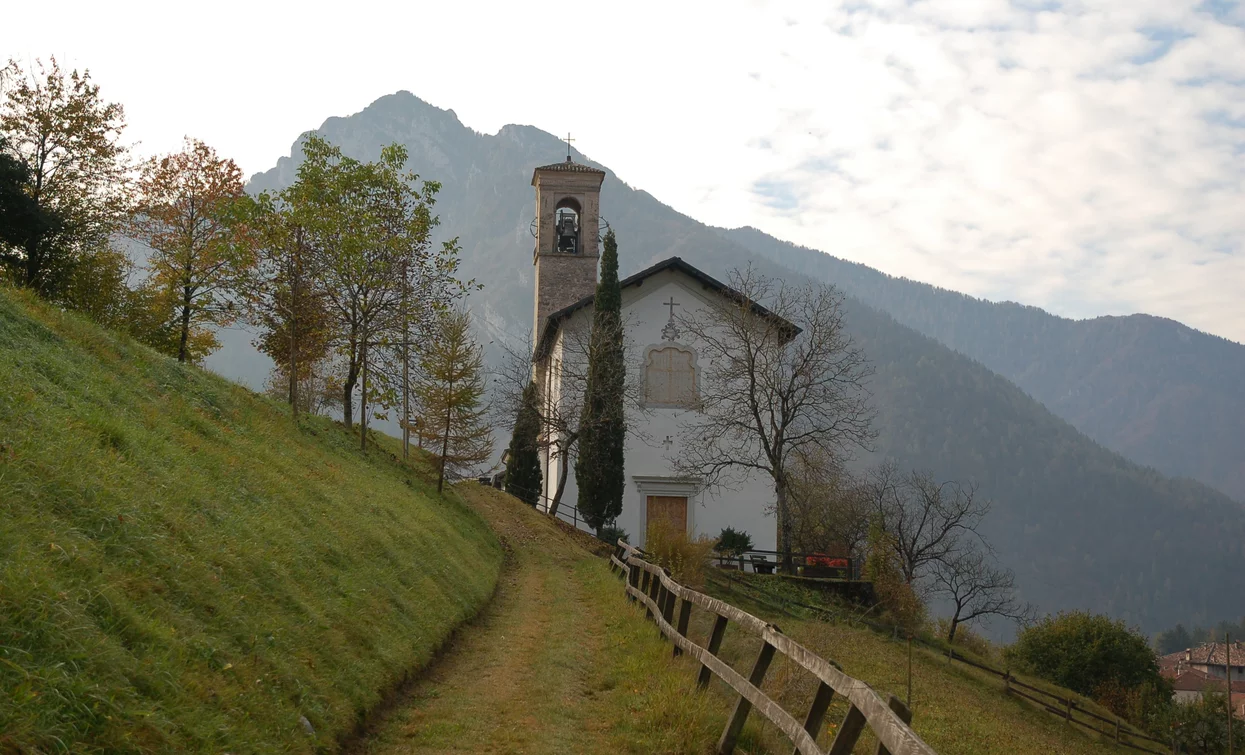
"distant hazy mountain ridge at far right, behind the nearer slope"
721,228,1245,501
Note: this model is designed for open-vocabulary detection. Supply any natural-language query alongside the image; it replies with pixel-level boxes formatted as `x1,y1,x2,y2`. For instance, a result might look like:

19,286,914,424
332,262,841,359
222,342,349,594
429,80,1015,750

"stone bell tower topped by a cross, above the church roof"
532,154,605,344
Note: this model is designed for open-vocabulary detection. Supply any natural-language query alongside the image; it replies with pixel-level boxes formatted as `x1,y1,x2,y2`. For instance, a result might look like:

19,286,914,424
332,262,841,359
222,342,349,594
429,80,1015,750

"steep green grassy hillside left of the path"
0,289,502,753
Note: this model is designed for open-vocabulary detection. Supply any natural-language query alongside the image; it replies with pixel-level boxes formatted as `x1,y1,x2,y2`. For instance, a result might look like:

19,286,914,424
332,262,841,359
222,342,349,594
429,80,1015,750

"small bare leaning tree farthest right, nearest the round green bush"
933,547,1033,643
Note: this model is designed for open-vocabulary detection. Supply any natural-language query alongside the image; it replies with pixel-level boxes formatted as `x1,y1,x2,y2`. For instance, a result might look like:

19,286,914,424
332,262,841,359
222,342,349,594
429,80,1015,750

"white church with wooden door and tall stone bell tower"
532,157,776,549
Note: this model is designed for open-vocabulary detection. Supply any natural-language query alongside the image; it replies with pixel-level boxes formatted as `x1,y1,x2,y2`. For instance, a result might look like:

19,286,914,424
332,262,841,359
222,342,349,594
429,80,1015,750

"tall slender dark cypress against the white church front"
575,230,626,531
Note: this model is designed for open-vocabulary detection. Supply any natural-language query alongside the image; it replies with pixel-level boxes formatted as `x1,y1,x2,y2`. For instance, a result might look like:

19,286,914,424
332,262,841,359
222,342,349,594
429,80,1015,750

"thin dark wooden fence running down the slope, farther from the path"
720,573,1175,755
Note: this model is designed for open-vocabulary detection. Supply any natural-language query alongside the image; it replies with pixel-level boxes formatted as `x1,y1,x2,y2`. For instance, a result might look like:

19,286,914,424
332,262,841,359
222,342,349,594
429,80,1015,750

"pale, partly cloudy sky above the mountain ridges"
0,0,1245,343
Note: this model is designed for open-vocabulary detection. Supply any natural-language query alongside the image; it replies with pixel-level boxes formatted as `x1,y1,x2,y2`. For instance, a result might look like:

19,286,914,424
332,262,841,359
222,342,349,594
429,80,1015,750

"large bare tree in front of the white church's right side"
675,268,874,572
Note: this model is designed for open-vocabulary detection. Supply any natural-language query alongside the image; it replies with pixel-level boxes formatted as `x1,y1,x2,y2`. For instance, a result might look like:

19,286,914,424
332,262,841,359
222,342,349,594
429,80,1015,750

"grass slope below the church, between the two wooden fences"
693,578,1140,755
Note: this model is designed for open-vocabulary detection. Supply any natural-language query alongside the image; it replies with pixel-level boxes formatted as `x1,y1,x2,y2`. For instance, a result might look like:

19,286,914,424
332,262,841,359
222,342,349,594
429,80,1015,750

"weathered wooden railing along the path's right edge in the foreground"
610,541,935,755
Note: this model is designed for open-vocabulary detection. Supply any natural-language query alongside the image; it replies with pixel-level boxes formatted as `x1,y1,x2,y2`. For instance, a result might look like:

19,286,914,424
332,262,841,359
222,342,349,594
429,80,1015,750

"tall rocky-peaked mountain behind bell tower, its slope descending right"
242,92,1245,630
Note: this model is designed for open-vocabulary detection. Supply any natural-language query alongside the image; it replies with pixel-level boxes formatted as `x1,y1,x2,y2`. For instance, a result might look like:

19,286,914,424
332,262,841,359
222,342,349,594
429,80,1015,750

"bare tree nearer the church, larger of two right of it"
867,462,990,588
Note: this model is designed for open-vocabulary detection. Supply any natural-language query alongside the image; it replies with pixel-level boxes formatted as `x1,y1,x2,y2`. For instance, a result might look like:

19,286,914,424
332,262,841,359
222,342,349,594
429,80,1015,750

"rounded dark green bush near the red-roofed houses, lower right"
1008,610,1162,696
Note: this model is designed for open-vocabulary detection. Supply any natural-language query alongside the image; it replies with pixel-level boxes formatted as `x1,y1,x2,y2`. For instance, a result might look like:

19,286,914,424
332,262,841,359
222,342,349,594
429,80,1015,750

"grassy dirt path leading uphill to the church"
360,486,713,755
